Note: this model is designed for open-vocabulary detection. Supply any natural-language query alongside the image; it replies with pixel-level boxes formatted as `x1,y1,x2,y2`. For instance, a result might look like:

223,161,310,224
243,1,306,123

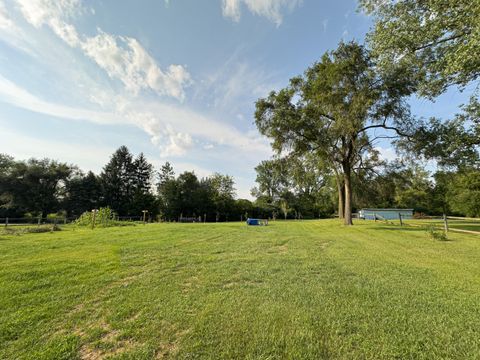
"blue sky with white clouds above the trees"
0,0,465,198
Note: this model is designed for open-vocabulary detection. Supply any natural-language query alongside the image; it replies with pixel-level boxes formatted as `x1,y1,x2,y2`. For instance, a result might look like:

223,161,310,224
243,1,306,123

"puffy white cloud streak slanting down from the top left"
13,0,191,100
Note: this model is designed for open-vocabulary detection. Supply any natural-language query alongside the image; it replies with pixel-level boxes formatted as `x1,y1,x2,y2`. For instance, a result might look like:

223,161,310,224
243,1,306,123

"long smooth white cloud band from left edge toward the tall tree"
0,71,270,156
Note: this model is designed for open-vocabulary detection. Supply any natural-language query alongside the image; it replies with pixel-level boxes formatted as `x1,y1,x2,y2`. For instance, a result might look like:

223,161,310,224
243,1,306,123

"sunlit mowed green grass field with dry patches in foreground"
0,220,480,359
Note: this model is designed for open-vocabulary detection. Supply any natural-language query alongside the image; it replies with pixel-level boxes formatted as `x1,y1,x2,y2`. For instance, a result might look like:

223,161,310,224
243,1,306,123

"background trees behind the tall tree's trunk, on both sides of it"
252,156,480,219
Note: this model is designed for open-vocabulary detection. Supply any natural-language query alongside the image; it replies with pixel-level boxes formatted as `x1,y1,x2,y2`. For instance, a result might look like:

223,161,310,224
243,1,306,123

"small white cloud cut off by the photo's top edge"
222,0,302,26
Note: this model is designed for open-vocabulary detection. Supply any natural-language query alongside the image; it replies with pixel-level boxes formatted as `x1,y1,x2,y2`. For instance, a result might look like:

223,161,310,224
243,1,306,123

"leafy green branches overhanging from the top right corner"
360,0,480,97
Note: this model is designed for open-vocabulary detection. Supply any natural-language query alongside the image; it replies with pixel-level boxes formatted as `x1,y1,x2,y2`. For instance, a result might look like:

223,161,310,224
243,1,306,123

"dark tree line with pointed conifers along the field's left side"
0,146,272,221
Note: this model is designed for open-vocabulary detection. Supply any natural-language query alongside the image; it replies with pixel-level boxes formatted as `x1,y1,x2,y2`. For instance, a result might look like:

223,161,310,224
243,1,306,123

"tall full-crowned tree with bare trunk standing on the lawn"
255,42,411,225
